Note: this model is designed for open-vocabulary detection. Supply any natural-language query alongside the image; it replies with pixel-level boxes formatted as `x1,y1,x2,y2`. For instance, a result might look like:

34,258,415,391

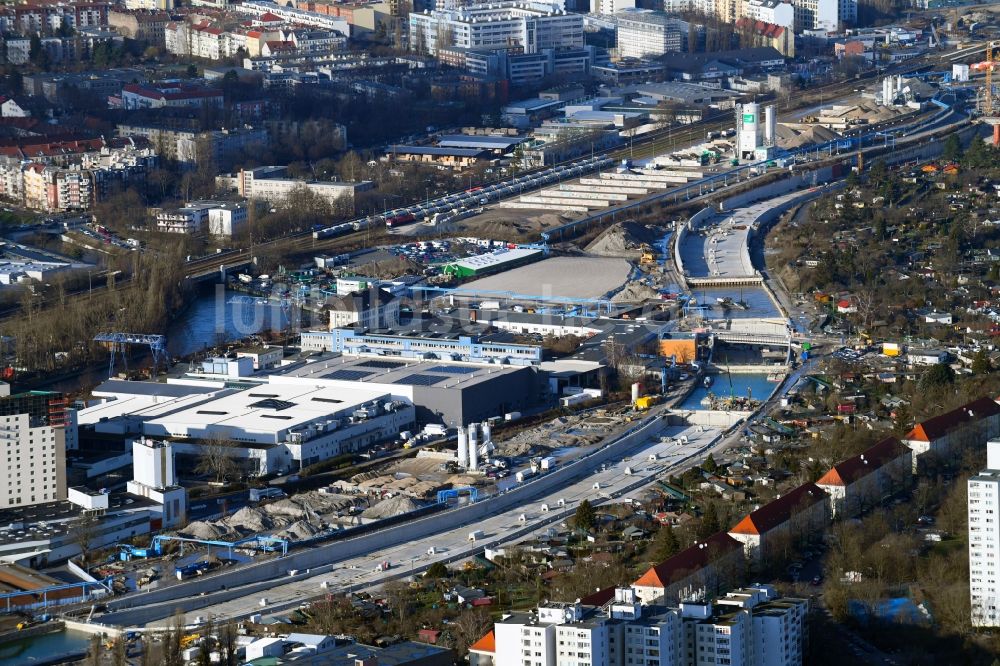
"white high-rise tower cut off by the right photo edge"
968,439,1000,627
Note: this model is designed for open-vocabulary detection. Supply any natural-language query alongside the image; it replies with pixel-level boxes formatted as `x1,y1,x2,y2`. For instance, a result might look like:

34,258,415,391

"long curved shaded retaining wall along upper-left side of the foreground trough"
101,415,665,625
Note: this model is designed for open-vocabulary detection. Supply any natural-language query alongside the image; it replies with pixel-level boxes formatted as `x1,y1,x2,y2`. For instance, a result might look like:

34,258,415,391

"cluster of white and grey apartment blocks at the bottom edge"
488,586,808,666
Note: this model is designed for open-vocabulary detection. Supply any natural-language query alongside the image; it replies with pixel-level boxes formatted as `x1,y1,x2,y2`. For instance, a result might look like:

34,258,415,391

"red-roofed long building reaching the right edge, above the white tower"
903,398,1000,471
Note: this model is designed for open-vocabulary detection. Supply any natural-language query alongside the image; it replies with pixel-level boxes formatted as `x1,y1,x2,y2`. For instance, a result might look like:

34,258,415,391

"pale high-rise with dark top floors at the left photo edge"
0,384,70,509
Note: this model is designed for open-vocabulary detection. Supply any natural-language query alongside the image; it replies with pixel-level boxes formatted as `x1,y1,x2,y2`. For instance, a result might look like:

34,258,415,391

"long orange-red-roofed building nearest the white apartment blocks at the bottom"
632,532,743,604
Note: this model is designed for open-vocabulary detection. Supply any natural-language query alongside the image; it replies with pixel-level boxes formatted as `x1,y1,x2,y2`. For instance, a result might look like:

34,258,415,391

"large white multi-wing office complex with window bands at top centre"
410,1,583,55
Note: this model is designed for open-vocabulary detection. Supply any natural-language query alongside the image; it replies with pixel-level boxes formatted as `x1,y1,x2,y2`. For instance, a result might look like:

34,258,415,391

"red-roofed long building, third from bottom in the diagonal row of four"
816,437,913,518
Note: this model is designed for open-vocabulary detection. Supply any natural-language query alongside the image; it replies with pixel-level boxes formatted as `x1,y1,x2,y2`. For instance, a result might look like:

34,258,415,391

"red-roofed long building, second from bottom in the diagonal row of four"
729,483,829,561
